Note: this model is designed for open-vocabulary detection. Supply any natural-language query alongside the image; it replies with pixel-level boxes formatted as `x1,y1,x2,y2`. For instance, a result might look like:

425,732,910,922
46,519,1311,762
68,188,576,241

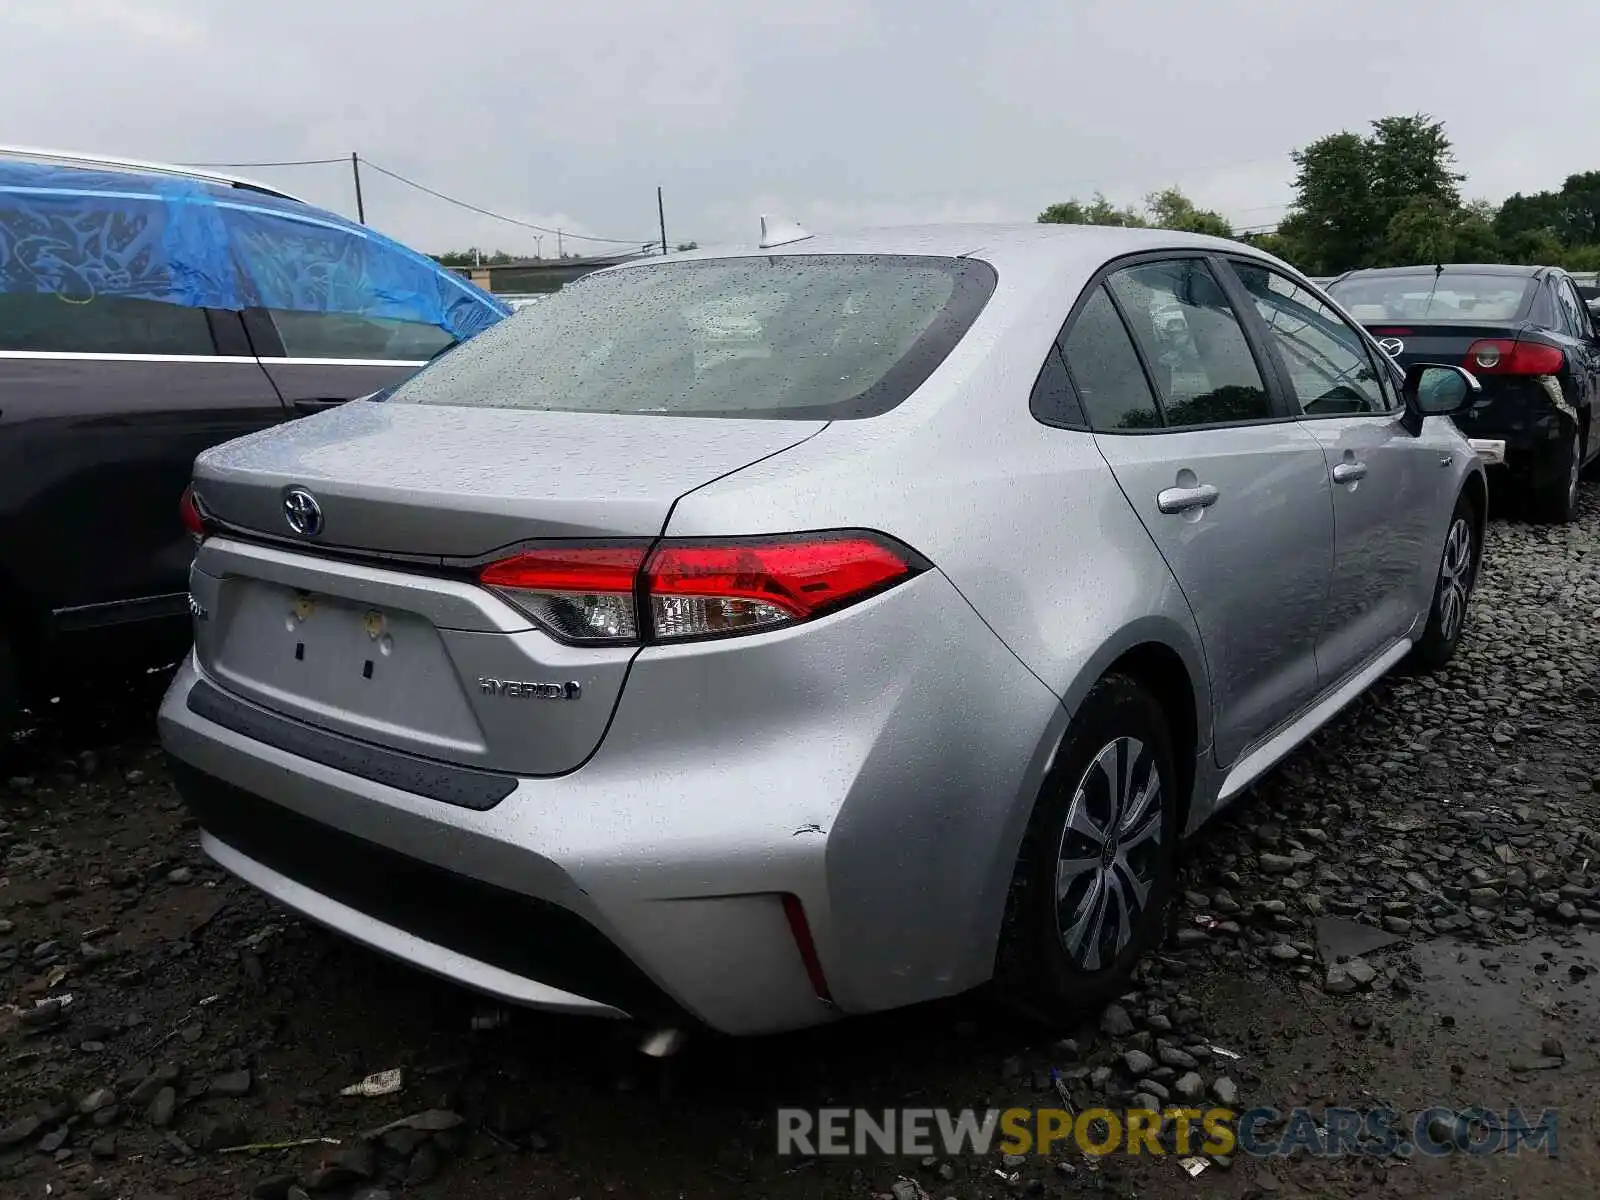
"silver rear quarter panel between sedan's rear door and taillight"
666,267,1211,972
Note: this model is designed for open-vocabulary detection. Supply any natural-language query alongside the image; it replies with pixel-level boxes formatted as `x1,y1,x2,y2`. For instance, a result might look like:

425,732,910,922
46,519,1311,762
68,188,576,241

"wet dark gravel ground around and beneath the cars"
0,488,1600,1200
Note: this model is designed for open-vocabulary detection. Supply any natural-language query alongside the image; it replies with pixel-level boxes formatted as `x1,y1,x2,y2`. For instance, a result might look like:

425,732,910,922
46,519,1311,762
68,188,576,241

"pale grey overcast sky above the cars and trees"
0,0,1600,254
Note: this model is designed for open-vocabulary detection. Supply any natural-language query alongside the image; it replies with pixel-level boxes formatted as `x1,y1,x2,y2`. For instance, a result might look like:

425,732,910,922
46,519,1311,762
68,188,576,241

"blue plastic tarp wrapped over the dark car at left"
0,160,510,339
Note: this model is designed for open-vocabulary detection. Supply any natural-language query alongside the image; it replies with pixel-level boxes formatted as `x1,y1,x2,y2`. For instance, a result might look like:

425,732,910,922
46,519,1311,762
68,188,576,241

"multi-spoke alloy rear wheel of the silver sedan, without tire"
1056,738,1165,971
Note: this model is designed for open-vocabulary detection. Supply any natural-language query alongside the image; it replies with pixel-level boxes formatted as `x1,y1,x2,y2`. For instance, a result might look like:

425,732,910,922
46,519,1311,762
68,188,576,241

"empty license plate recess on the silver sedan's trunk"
208,576,485,760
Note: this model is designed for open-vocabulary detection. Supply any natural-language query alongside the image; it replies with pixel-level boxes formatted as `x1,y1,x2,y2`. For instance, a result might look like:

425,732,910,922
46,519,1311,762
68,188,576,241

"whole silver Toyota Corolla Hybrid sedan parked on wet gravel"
160,226,1486,1034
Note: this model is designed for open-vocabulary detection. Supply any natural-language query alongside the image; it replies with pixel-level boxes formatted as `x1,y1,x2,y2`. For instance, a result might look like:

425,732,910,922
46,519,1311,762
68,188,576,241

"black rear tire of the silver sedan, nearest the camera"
995,675,1179,1019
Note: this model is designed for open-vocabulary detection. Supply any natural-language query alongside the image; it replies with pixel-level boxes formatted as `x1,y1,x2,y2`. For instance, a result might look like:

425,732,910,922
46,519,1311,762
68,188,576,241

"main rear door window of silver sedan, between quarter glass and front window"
1109,258,1274,426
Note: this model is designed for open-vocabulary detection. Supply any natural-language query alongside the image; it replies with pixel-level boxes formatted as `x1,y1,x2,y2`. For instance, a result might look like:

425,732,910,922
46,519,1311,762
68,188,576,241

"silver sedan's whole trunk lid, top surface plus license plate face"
190,402,824,776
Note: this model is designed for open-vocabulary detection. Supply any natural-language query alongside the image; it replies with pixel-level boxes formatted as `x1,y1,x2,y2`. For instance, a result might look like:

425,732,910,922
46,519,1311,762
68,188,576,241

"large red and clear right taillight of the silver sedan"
478,531,926,645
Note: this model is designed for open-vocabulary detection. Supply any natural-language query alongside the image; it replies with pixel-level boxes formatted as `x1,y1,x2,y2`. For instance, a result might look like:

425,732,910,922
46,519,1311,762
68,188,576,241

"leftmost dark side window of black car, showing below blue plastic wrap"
0,291,216,355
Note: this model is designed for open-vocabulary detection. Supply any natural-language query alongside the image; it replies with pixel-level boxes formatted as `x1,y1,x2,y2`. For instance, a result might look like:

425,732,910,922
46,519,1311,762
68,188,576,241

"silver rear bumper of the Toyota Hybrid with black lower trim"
160,573,1062,1034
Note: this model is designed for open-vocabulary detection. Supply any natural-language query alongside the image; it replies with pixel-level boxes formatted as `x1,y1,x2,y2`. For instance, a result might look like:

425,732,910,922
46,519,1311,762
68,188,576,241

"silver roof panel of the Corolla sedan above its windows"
624,222,1267,278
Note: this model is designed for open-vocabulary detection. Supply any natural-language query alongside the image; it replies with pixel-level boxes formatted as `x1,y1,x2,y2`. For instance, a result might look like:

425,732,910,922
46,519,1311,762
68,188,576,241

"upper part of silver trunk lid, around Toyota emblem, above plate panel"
195,400,826,558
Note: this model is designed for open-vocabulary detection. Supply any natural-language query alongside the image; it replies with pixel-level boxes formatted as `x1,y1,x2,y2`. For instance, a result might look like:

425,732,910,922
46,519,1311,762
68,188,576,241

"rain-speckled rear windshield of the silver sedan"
380,254,995,419
